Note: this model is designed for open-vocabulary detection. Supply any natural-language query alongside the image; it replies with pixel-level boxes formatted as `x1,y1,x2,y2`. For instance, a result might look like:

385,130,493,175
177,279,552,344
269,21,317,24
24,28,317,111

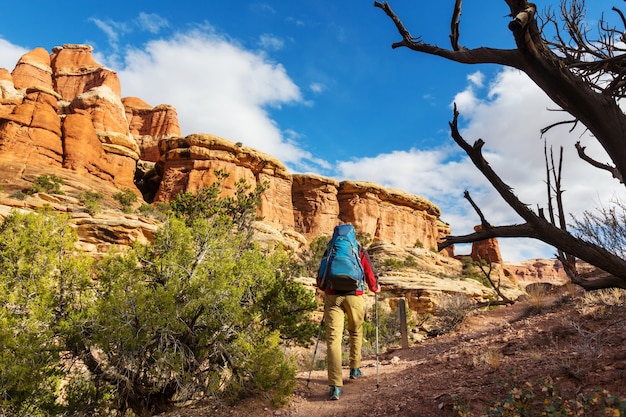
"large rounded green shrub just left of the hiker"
75,217,315,414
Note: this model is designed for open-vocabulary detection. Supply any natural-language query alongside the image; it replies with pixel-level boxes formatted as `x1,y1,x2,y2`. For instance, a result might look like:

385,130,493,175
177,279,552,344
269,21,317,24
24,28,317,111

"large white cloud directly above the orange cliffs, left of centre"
118,31,313,166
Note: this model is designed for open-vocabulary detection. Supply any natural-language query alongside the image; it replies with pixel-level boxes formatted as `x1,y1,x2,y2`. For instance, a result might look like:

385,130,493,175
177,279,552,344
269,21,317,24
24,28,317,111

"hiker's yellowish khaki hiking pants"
324,294,365,387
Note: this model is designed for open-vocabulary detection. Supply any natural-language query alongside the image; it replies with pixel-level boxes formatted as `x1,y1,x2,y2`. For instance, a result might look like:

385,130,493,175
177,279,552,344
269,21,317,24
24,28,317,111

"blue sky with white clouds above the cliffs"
0,0,623,261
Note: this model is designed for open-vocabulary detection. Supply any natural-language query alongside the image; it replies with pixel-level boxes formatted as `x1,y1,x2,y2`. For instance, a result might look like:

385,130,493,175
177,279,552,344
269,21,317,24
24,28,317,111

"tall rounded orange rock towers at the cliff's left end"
0,45,180,193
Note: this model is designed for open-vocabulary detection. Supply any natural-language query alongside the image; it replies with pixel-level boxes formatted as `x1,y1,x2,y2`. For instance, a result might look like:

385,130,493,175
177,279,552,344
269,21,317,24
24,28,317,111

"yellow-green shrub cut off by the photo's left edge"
0,212,92,416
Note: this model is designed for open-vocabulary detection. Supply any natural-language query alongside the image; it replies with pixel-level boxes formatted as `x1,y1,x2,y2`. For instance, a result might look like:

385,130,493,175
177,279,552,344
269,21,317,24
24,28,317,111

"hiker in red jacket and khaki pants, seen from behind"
317,224,380,400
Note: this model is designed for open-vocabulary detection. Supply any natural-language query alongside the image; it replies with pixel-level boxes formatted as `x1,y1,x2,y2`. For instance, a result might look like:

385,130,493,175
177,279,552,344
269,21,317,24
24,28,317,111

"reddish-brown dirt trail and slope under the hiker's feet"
161,292,626,417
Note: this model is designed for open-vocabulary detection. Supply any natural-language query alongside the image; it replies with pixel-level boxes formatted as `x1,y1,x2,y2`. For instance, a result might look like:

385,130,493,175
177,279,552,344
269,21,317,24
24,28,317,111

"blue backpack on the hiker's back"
317,224,363,292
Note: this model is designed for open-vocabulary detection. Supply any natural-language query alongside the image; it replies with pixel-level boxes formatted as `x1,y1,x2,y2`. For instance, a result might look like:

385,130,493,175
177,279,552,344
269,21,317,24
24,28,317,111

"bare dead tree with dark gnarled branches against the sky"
374,0,626,290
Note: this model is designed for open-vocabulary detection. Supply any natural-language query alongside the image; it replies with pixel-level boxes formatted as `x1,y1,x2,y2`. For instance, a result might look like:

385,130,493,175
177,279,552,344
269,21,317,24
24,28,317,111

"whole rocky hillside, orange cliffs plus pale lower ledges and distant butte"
0,45,564,311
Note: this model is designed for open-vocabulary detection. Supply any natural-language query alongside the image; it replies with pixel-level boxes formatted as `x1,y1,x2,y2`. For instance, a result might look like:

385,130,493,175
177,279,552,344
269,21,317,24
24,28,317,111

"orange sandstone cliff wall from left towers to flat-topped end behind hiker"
0,45,452,255
